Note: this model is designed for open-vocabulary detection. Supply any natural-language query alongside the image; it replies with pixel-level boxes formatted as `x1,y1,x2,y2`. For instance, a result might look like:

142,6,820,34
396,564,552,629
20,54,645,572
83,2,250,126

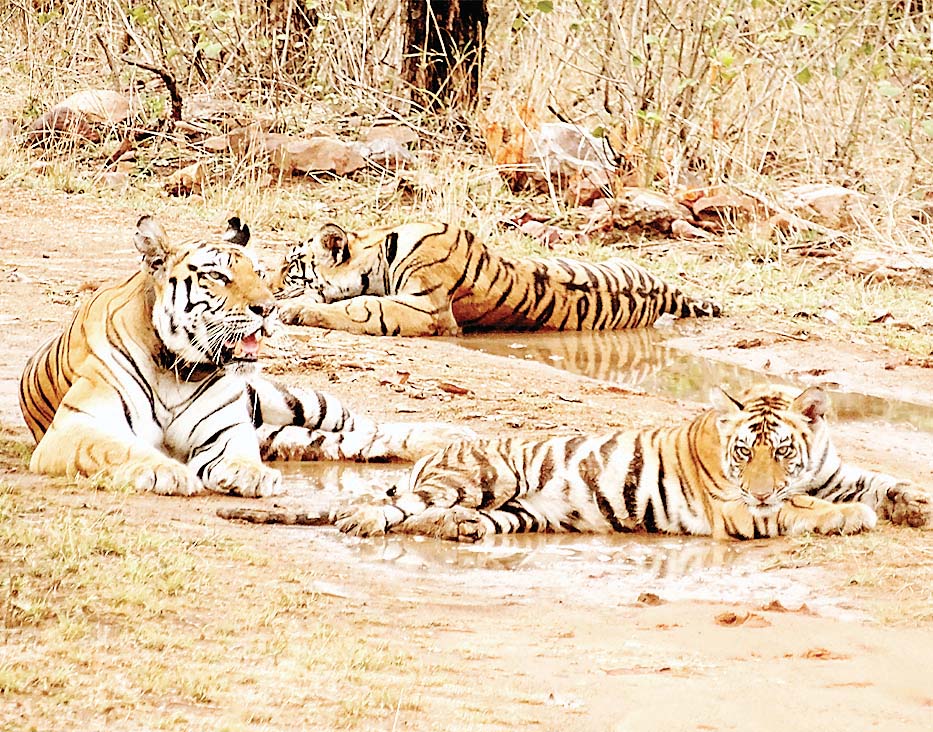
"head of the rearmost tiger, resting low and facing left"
272,224,386,302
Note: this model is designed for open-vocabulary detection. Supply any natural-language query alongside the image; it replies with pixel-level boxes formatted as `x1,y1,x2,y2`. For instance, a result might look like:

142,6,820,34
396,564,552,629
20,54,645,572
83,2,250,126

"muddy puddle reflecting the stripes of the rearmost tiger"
451,328,933,432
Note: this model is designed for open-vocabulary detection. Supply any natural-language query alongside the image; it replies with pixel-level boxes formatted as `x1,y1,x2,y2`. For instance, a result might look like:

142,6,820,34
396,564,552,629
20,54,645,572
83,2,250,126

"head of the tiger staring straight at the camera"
713,386,832,518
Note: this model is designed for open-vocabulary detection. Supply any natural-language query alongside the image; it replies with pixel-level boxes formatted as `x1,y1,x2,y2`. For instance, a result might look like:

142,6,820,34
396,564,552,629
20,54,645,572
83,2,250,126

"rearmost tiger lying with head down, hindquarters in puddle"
273,223,720,336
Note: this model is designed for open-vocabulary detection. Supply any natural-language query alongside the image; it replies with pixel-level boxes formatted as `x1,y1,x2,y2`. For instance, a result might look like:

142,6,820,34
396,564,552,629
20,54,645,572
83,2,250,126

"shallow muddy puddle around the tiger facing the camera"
276,462,855,617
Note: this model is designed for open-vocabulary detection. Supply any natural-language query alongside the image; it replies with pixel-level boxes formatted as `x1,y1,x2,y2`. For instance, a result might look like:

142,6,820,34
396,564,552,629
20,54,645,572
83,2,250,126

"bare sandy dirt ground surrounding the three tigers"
0,189,933,732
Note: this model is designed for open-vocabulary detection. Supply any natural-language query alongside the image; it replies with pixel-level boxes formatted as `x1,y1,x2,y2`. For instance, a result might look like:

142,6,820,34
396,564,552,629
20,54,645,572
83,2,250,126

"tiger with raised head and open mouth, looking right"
20,216,472,496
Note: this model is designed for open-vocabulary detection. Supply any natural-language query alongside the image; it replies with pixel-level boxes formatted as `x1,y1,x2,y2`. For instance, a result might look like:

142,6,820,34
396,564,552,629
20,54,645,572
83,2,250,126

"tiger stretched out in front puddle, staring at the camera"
334,387,933,541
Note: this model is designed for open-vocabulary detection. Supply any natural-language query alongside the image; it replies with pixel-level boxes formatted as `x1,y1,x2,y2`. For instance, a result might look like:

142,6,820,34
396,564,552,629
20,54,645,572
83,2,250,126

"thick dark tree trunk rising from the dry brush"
402,0,489,109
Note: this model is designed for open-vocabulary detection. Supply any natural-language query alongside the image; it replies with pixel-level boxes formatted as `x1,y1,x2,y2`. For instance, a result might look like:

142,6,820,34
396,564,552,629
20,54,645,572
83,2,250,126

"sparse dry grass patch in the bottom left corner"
0,478,429,729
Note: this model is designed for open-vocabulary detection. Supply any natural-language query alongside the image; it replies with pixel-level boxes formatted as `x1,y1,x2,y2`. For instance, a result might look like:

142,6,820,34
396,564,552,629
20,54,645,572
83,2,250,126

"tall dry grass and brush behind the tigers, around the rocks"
0,0,933,354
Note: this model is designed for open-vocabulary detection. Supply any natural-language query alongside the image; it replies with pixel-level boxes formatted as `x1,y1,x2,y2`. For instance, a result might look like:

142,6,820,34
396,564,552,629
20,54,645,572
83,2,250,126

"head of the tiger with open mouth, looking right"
135,216,277,366
